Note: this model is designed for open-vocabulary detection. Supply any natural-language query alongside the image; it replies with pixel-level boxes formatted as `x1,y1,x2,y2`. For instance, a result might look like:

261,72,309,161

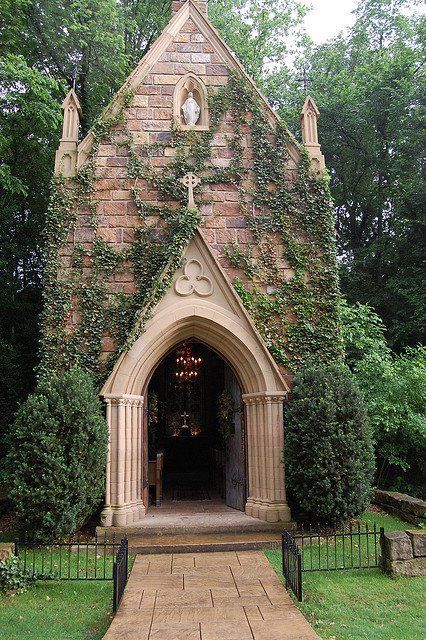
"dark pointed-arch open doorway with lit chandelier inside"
145,340,247,511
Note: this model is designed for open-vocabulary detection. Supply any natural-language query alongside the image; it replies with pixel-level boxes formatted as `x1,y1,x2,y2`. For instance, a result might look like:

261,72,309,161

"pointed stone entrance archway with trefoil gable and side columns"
101,233,291,526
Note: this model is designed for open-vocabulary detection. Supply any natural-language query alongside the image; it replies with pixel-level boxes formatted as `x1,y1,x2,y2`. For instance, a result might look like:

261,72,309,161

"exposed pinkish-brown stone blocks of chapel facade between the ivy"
61,20,295,358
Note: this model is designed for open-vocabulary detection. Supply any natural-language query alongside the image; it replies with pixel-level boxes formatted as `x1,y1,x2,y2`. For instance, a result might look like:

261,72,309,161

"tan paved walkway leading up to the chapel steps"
104,551,319,640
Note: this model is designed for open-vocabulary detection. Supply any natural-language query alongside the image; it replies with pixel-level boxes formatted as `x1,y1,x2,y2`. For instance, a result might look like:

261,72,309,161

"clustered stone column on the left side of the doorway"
101,394,145,526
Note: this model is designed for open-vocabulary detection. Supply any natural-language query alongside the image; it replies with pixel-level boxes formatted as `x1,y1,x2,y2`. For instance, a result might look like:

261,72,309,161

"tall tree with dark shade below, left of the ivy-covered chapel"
0,55,61,455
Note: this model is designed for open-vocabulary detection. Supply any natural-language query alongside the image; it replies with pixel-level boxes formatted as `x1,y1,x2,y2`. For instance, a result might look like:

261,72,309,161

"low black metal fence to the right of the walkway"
282,523,384,600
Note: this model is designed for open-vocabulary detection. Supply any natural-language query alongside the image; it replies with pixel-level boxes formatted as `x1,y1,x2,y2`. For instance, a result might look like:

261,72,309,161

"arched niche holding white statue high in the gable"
173,74,209,131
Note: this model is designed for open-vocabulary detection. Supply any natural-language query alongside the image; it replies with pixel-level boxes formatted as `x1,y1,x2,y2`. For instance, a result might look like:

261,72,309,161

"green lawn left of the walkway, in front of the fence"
0,580,112,640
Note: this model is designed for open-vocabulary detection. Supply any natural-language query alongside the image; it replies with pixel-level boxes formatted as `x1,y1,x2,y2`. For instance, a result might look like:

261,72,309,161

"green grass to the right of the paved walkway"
265,512,426,640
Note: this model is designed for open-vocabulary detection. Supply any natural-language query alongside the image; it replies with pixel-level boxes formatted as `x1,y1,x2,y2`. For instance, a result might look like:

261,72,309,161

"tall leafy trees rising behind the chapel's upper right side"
277,0,426,350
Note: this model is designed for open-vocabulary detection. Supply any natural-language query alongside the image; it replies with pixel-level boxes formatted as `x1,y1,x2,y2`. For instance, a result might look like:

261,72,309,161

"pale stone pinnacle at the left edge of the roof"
55,89,82,178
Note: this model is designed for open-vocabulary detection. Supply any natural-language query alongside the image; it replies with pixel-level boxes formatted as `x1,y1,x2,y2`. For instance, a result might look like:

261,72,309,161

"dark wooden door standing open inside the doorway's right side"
225,366,246,511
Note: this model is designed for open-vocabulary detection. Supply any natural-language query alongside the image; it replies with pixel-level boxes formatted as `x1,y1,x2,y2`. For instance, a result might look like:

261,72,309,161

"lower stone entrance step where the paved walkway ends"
122,532,281,554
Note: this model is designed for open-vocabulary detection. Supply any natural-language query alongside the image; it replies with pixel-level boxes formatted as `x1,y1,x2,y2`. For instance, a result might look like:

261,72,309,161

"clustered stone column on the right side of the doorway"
243,391,291,522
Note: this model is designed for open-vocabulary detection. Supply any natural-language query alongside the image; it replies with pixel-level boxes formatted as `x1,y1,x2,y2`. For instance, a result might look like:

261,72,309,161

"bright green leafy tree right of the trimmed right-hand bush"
341,303,426,497
